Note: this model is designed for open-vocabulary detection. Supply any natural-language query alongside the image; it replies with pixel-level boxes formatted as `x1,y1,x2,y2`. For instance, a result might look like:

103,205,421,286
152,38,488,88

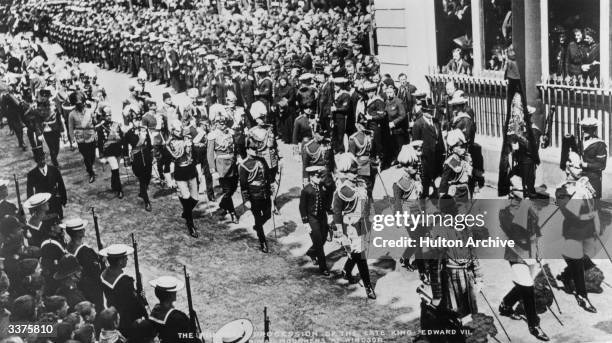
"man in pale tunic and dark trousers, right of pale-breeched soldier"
207,111,238,224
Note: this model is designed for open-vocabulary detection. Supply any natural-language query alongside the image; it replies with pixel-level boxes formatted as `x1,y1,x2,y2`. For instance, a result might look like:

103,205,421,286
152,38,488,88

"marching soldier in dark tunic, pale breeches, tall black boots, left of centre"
167,121,199,238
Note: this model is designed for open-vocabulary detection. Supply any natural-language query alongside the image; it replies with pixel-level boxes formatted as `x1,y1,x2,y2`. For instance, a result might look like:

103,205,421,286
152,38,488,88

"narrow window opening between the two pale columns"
483,0,512,71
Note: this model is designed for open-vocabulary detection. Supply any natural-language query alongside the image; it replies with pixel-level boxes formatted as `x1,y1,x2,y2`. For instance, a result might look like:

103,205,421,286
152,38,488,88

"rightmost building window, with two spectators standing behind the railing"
548,0,601,82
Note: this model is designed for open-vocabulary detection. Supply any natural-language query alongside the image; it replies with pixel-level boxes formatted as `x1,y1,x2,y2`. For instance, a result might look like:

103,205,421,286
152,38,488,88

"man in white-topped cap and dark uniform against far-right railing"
580,117,608,199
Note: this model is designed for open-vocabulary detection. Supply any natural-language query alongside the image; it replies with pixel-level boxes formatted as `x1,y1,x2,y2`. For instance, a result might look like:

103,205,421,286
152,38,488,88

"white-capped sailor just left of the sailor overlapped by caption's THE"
100,244,147,338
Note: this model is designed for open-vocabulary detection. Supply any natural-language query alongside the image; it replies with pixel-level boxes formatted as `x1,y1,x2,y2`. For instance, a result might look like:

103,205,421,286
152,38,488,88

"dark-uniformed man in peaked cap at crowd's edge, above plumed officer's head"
330,77,351,153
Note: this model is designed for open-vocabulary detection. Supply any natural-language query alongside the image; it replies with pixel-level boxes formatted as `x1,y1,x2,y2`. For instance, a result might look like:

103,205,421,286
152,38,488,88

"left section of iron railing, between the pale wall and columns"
425,72,508,137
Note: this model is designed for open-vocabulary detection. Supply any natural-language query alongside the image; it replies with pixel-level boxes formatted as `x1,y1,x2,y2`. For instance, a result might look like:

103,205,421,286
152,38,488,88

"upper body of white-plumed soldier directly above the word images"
440,129,473,199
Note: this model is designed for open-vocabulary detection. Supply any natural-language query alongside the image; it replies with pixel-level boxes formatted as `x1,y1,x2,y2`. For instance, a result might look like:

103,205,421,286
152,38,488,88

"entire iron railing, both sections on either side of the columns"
426,69,612,156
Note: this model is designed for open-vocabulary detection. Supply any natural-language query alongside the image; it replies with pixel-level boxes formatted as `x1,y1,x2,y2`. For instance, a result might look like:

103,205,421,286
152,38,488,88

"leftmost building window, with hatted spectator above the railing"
435,0,473,74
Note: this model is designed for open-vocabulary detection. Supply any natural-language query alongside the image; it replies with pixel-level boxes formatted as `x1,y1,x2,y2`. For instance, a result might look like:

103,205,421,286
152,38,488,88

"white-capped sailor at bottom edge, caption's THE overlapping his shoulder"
149,276,197,343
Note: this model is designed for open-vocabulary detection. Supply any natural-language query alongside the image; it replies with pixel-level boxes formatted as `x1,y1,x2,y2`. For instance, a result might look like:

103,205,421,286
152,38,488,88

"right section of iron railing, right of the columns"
537,75,612,156
